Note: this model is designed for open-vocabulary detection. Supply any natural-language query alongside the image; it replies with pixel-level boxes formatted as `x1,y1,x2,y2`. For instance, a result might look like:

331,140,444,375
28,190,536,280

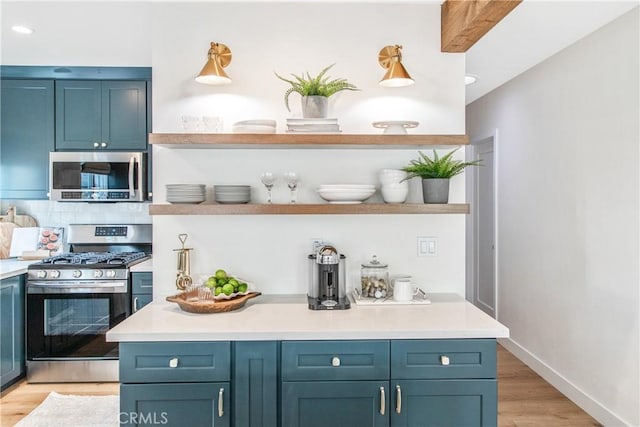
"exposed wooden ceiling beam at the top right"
440,0,522,52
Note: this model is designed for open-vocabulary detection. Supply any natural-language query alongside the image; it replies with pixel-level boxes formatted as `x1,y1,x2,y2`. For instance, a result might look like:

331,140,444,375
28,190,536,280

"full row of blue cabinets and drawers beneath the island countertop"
120,339,497,427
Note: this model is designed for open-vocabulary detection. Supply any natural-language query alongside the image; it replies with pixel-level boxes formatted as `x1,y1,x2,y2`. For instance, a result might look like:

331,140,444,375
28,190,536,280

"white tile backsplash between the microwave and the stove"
0,200,151,227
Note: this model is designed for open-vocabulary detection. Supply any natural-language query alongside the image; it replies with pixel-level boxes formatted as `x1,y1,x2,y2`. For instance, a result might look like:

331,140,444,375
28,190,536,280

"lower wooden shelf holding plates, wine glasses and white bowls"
149,203,469,215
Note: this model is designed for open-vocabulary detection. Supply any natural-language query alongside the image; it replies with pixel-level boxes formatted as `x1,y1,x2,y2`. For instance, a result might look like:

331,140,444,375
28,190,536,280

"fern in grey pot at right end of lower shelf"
402,148,480,203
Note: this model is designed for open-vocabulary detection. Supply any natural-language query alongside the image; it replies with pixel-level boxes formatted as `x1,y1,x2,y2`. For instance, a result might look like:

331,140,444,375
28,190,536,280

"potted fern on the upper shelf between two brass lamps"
274,64,358,118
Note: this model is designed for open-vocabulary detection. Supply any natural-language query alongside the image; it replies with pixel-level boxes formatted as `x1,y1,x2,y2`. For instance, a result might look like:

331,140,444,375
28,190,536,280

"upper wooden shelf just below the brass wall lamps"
149,133,469,149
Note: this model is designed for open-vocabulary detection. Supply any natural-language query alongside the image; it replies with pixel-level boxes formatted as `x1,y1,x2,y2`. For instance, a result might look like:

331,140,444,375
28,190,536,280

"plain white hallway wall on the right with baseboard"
467,8,640,426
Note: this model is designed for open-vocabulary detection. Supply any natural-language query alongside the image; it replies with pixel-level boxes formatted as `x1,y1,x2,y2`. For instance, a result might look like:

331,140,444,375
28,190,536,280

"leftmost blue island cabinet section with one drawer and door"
119,342,231,427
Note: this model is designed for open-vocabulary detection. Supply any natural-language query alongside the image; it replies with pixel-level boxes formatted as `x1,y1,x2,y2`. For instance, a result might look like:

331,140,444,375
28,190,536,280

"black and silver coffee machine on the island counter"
307,245,350,310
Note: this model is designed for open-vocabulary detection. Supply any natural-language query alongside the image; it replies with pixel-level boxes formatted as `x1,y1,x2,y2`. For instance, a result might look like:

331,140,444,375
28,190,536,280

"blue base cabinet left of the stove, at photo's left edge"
0,275,25,389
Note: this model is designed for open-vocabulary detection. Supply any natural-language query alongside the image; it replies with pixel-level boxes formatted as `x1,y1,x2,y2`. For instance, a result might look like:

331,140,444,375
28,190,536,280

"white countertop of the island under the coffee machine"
107,294,509,342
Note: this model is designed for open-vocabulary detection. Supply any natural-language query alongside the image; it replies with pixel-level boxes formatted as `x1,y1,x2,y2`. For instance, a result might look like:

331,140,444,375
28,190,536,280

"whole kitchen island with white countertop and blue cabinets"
107,294,509,427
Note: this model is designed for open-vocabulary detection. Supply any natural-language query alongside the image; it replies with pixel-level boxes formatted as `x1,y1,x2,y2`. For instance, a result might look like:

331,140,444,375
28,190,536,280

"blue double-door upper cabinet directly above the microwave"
55,80,147,151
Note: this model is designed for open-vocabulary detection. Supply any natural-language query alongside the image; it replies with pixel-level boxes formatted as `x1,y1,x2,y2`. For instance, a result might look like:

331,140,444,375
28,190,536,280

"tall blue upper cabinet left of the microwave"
0,79,54,199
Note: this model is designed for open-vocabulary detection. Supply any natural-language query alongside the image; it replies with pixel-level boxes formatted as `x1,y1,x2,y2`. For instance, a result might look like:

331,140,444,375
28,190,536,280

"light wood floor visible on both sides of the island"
0,346,601,427
